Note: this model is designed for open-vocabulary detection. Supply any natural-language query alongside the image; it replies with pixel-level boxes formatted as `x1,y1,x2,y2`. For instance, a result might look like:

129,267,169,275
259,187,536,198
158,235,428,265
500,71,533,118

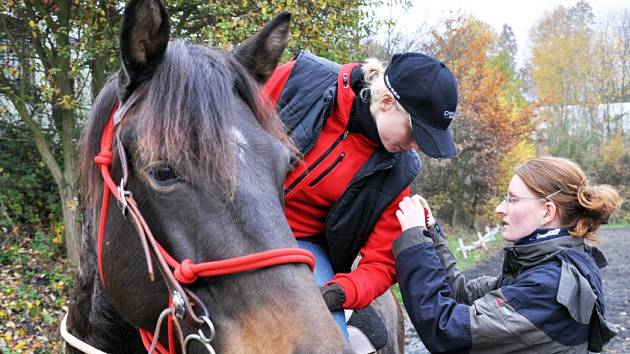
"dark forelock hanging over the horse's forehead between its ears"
128,41,235,196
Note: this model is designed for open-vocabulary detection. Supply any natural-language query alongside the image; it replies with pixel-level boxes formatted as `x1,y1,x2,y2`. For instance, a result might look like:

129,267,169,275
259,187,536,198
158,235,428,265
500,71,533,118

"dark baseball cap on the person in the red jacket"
385,53,457,158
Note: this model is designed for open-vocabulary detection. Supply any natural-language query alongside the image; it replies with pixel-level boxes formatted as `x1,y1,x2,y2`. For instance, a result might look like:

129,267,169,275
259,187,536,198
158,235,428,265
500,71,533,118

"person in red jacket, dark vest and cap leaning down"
263,52,457,338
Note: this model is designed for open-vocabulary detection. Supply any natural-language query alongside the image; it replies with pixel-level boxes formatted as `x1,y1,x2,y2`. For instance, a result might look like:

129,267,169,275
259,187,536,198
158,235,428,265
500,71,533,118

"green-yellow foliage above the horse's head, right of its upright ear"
168,0,381,62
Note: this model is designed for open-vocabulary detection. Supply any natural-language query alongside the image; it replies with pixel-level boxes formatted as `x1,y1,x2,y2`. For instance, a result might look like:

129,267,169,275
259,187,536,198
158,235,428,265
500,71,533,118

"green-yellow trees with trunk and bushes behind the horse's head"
0,0,382,262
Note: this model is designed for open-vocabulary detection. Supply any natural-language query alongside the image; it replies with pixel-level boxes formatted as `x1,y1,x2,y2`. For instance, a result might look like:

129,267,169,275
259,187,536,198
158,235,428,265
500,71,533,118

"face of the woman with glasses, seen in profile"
495,175,547,241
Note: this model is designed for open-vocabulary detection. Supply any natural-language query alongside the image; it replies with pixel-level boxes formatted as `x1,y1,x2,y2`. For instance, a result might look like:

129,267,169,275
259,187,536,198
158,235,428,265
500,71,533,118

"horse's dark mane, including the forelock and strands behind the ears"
80,40,295,214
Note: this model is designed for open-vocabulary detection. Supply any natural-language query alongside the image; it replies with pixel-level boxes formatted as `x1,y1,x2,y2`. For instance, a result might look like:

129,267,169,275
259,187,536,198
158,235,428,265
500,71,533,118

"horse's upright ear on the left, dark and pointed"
118,0,170,102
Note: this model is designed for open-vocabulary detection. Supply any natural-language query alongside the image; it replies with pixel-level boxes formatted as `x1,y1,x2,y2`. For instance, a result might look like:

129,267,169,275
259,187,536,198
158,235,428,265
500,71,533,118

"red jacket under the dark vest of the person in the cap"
263,61,410,308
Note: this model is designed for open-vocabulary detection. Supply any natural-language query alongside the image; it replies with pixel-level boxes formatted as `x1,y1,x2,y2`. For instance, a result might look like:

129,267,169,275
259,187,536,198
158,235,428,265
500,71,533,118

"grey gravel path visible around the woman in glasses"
405,228,630,354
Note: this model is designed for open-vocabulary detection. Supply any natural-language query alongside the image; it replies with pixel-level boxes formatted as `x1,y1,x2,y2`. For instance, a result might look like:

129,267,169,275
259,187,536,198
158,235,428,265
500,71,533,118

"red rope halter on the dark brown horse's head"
94,97,315,354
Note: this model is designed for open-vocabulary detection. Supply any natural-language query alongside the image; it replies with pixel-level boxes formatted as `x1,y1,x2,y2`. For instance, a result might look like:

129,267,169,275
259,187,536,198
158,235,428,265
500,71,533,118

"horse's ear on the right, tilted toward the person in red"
232,11,291,83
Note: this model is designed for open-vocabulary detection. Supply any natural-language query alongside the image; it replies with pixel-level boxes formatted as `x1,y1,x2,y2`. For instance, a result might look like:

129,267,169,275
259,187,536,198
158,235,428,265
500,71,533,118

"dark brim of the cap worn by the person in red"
411,116,457,159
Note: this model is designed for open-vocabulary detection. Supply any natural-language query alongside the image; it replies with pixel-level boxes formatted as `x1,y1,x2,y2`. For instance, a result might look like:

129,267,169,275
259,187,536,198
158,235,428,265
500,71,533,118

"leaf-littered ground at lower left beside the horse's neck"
0,231,73,354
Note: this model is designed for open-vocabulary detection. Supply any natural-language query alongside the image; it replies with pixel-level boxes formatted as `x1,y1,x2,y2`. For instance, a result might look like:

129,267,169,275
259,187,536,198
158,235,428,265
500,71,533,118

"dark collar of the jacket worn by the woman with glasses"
503,229,586,274
